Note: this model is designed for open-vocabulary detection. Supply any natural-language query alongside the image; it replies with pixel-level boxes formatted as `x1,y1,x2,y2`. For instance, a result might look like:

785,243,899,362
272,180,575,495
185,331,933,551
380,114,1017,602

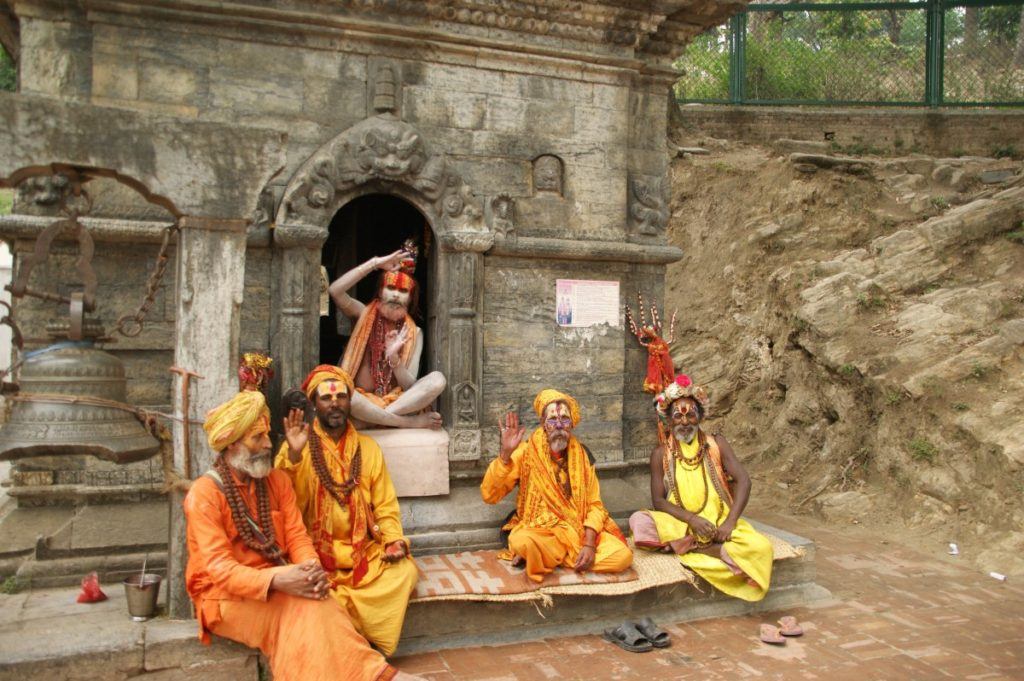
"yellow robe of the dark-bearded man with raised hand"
274,421,419,655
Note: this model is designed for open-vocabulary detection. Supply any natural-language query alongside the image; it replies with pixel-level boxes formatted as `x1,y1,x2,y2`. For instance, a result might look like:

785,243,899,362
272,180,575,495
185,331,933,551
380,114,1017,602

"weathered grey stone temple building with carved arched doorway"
0,0,743,614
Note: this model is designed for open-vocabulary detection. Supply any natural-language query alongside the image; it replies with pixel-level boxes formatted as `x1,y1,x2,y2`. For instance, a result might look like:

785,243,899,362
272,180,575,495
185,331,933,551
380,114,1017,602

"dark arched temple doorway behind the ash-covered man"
319,194,434,376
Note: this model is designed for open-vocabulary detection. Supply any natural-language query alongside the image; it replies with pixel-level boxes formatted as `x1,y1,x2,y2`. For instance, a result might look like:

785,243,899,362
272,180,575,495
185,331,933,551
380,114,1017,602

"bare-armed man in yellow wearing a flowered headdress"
630,375,772,601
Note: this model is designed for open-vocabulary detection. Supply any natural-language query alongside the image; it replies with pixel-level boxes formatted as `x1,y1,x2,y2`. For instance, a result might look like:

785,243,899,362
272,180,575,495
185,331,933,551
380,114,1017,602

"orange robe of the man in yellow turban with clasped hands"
184,471,395,681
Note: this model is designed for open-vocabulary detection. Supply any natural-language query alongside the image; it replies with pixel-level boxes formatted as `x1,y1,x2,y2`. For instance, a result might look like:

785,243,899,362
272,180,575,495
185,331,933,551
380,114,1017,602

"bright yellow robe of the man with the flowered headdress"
643,437,773,601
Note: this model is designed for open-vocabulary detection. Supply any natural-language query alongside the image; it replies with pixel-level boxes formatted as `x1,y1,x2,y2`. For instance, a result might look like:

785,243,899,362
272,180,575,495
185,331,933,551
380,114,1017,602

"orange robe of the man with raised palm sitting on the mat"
480,428,633,582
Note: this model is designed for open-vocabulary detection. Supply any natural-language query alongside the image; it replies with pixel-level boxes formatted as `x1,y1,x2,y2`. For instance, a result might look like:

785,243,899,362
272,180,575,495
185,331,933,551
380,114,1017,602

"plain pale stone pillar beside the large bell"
167,217,246,619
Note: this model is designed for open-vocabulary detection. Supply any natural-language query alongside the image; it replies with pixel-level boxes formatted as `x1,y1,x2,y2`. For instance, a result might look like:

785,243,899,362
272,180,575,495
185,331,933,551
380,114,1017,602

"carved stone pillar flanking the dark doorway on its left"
270,224,327,393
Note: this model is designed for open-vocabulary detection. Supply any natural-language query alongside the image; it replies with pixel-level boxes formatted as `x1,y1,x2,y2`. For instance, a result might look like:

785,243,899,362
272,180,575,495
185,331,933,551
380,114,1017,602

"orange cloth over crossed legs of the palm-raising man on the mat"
509,525,633,582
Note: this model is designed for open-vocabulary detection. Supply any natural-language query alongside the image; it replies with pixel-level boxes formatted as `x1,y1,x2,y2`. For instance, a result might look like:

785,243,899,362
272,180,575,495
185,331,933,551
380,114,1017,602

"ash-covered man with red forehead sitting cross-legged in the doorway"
328,242,445,429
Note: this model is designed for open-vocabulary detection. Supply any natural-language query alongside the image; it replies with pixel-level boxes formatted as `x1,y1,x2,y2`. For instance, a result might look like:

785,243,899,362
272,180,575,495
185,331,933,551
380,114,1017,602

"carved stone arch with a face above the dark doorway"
275,114,487,235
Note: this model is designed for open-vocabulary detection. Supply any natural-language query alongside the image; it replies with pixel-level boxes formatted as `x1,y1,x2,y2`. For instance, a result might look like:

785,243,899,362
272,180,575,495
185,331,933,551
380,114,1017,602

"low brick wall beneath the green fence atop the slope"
677,105,1024,156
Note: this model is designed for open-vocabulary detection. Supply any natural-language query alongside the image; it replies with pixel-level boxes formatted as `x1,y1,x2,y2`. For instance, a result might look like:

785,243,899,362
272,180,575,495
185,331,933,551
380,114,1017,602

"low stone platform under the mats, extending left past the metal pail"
0,525,829,681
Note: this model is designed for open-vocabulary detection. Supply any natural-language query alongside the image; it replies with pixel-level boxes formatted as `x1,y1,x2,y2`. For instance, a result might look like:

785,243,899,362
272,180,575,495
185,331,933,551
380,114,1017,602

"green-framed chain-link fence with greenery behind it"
676,0,1024,105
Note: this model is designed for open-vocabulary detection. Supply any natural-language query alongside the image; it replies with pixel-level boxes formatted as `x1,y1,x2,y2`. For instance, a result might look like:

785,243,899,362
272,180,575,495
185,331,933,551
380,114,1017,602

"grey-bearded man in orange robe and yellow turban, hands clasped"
184,390,416,681
